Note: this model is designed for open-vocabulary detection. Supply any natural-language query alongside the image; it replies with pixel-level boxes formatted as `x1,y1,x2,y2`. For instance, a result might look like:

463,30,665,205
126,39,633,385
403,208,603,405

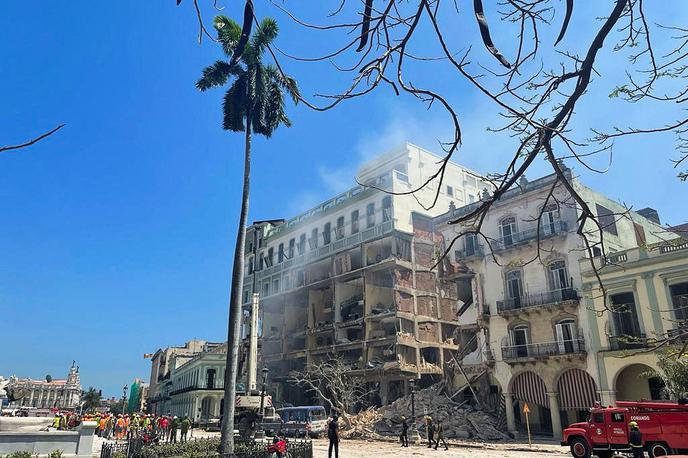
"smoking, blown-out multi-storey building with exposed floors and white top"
243,144,489,404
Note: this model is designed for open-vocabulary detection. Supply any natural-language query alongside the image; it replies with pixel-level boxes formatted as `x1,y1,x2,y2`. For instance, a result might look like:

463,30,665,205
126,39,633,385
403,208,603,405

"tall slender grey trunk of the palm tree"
220,114,251,456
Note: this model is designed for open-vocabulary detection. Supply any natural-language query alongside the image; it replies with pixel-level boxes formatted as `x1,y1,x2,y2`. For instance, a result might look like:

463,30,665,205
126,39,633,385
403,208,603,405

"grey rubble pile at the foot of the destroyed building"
342,383,509,441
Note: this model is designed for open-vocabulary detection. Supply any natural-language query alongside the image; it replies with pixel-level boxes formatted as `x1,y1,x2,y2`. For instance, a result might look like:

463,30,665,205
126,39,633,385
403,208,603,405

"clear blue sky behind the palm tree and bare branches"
0,0,688,395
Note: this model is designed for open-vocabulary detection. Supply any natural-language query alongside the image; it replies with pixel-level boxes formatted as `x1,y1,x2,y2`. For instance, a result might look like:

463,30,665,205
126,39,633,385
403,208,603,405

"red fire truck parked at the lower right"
561,399,688,458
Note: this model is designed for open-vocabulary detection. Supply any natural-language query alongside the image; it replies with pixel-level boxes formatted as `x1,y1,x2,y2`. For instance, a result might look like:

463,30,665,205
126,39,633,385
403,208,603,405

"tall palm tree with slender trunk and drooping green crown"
196,16,299,454
